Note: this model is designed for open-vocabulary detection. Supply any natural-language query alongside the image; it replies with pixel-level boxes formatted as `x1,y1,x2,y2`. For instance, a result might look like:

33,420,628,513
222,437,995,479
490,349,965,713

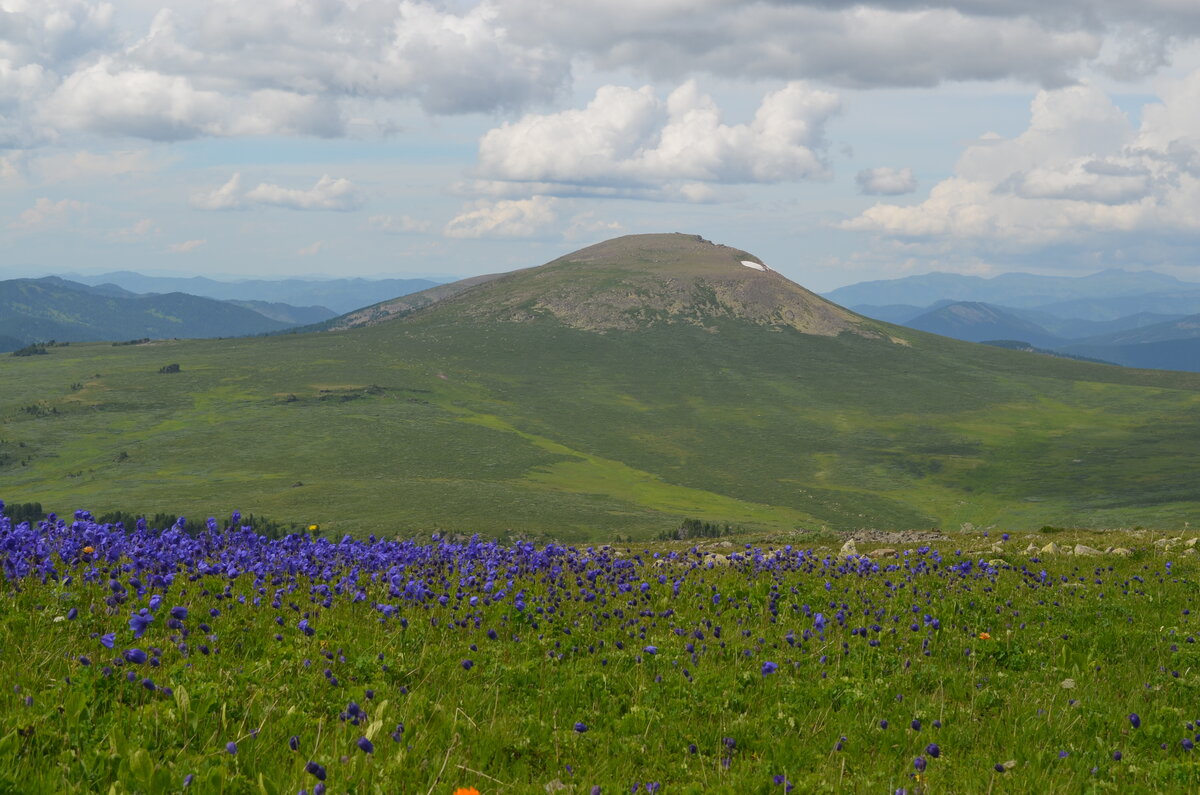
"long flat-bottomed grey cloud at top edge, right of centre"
503,0,1104,88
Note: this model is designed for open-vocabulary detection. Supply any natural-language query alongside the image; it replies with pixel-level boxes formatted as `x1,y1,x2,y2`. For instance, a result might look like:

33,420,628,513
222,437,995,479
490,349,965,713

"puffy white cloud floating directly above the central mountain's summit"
478,80,840,201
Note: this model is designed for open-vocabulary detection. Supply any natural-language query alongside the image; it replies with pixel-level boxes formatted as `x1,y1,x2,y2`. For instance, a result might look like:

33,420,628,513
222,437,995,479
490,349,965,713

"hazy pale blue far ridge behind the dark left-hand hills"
70,270,438,314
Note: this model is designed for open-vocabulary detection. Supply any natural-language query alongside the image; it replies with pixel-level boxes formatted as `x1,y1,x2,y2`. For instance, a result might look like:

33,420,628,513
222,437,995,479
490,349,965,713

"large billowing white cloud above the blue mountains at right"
841,71,1200,246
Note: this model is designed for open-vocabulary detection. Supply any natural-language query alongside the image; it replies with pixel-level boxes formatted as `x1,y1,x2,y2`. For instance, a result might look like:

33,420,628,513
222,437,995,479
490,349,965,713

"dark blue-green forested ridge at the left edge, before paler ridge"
0,276,292,351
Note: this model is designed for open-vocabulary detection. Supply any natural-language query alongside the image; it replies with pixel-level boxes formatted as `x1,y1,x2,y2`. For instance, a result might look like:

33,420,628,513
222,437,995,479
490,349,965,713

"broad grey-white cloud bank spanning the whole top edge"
0,0,1200,151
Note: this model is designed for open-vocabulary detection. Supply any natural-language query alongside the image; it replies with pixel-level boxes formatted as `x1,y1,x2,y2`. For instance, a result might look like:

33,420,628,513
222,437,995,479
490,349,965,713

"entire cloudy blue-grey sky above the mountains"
7,0,1200,291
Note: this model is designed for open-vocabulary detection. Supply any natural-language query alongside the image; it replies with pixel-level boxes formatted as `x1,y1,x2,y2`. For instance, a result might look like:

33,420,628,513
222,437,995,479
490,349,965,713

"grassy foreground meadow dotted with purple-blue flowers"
0,506,1200,795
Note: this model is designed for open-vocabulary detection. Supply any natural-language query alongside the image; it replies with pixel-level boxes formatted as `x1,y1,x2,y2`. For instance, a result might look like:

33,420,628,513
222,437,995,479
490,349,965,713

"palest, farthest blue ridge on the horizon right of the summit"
826,270,1200,319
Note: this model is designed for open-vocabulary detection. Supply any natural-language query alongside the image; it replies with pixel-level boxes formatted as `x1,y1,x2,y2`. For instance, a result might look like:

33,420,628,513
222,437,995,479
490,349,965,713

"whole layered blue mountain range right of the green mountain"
826,270,1200,371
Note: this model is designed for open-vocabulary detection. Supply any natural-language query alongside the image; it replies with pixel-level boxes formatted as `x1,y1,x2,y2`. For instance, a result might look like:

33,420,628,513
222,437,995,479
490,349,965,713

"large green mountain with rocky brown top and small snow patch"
0,235,1200,543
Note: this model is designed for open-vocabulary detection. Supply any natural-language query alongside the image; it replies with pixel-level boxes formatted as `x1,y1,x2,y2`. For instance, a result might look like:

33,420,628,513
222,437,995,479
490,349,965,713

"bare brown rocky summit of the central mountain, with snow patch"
326,234,890,337
